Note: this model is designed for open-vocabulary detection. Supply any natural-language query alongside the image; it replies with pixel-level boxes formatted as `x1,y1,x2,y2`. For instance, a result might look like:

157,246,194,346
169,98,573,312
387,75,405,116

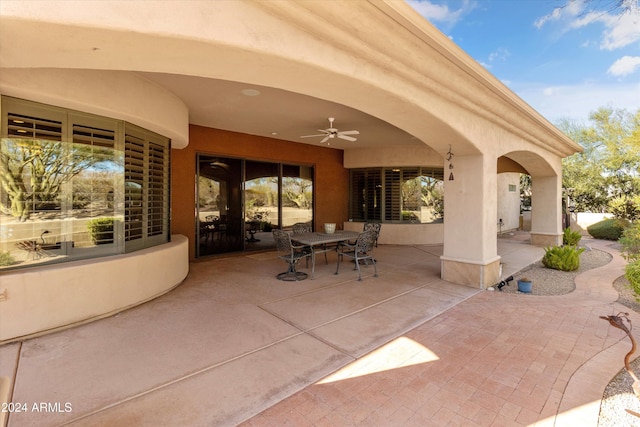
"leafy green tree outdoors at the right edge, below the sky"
558,108,640,217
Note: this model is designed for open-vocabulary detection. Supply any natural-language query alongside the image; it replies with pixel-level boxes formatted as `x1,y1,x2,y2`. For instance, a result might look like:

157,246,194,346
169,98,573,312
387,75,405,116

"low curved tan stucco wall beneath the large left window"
0,235,189,343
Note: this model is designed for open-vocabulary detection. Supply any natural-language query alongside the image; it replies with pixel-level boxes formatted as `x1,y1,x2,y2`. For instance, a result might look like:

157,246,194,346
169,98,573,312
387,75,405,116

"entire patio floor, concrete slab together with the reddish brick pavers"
0,239,640,427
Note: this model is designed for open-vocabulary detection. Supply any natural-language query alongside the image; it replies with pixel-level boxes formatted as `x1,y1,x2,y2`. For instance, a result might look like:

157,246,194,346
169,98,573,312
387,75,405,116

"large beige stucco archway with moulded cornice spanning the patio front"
0,0,576,296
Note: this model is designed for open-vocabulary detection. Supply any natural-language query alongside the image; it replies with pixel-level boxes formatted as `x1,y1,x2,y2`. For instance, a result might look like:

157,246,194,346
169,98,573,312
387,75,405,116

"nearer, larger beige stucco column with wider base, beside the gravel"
440,155,500,289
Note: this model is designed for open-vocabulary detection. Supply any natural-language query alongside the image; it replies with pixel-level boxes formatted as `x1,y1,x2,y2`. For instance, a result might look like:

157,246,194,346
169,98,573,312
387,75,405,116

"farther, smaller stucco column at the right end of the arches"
531,176,562,246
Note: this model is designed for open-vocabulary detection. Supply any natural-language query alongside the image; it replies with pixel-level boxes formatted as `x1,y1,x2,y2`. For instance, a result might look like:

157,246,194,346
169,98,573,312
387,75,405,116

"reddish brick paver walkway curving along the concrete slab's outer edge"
242,240,640,427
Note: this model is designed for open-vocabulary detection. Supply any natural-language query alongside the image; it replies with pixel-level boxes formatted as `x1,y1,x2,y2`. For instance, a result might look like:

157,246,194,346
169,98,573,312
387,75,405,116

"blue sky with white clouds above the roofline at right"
408,0,640,123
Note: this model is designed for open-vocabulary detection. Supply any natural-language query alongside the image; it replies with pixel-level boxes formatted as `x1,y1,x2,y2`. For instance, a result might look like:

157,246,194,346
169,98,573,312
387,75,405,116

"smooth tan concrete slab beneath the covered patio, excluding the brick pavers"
0,239,543,426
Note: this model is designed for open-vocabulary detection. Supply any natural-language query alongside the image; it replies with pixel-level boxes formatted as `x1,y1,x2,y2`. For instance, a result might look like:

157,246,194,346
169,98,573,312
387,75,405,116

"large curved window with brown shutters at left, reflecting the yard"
0,96,170,270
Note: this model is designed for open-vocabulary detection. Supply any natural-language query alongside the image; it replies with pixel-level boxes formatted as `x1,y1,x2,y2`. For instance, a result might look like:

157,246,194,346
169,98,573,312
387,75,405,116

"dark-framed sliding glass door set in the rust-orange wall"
195,154,313,257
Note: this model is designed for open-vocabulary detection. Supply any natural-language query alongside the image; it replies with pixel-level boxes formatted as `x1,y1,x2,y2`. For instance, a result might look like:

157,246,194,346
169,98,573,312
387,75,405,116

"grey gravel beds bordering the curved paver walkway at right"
496,242,640,427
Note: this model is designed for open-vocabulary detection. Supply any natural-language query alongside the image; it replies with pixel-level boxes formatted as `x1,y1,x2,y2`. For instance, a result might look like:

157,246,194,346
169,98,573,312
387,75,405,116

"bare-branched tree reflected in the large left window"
0,138,107,221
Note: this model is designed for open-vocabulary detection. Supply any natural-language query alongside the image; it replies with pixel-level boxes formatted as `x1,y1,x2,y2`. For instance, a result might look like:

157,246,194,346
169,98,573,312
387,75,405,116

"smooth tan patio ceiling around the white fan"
140,73,422,150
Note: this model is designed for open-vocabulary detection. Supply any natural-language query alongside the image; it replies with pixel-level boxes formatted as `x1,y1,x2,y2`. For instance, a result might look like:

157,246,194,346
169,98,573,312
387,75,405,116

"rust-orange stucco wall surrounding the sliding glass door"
171,125,349,259
